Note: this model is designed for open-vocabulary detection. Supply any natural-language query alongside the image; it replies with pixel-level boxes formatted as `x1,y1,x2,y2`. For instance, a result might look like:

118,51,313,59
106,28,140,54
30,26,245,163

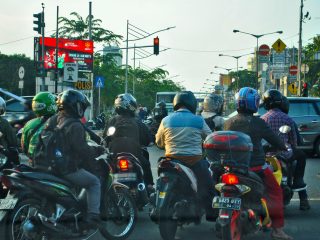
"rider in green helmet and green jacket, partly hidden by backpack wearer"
21,92,57,161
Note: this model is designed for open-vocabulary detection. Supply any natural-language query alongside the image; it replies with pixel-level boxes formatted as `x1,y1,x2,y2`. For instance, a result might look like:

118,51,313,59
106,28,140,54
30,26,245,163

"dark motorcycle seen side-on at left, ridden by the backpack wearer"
0,141,137,240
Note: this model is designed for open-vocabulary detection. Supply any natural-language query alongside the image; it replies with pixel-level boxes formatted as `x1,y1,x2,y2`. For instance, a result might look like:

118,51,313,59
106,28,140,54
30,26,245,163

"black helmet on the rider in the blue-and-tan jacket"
173,91,197,114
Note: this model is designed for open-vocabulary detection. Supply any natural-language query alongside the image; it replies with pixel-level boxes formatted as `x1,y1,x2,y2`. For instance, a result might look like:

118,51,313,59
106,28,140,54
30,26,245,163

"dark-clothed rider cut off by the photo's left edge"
0,97,19,163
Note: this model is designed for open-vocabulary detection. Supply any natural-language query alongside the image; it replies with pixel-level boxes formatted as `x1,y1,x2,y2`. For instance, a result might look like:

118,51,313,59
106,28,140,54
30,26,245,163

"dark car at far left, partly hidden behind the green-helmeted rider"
3,96,33,126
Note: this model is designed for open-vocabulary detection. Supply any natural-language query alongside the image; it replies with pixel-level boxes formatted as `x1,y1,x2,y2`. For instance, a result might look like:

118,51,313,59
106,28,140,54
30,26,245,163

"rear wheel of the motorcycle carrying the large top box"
221,211,242,240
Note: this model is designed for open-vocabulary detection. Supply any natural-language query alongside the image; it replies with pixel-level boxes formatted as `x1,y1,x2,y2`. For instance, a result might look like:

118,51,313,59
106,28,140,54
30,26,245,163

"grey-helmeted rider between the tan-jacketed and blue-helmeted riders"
201,93,224,131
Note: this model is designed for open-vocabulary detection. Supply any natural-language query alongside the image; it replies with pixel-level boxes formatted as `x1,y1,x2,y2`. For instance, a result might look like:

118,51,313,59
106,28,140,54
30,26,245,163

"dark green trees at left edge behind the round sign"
0,53,35,95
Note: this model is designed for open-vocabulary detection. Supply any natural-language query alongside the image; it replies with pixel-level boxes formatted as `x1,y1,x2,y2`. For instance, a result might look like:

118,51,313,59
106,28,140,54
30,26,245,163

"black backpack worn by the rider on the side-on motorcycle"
32,115,79,176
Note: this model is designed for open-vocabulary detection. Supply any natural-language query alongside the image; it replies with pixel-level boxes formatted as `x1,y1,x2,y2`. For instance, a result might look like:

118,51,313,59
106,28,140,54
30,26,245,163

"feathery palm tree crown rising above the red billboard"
52,12,122,44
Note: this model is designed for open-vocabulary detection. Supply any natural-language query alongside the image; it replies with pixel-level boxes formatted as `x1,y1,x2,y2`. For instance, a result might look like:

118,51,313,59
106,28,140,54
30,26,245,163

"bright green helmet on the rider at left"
32,92,57,116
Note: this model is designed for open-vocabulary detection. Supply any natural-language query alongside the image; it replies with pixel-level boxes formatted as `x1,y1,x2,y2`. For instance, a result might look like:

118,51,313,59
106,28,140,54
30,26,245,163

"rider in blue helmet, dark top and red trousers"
224,87,292,240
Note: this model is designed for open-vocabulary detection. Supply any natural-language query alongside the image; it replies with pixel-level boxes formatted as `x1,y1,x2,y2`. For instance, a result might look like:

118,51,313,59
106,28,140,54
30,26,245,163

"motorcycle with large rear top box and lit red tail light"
204,131,271,240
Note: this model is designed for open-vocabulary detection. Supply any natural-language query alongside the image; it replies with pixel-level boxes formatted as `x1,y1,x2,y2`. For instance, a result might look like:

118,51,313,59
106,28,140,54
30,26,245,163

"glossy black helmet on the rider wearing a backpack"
57,89,90,118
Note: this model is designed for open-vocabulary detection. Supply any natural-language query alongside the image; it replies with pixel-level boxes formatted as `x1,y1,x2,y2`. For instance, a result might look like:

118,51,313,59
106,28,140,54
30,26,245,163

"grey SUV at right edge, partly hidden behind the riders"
224,97,320,156
